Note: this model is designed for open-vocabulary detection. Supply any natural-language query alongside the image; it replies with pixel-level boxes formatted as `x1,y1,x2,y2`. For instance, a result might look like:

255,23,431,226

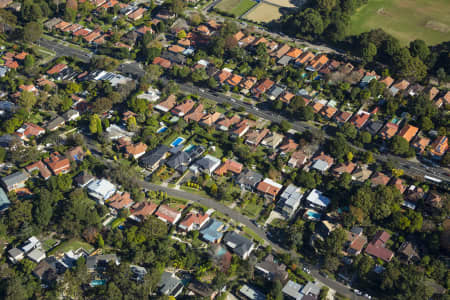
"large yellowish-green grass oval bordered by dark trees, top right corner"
350,0,450,45
